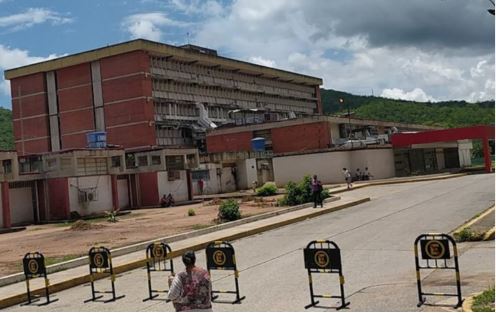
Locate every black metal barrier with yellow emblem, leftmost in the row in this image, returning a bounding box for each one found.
[22,252,58,306]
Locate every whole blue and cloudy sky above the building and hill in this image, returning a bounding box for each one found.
[0,0,495,108]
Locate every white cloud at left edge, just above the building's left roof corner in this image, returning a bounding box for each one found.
[0,44,63,96]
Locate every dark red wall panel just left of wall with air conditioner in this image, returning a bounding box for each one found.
[47,177,70,220]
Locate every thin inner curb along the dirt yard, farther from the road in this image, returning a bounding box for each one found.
[0,196,341,287]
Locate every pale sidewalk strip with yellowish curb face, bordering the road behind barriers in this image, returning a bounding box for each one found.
[0,198,370,309]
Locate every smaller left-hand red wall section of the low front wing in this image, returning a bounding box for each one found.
[207,131,253,153]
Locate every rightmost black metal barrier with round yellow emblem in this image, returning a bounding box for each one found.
[414,233,463,308]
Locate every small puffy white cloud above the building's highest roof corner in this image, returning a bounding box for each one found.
[122,12,188,41]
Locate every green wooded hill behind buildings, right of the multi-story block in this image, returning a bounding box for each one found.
[320,89,494,127]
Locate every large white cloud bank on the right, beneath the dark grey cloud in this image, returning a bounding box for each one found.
[192,0,494,101]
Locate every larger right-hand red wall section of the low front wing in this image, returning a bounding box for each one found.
[271,122,331,153]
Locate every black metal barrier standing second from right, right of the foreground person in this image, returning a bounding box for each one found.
[303,240,350,310]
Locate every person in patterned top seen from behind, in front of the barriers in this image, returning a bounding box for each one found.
[168,251,212,312]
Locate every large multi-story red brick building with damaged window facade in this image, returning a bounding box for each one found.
[5,39,322,156]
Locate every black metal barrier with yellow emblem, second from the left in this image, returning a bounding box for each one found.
[84,247,125,303]
